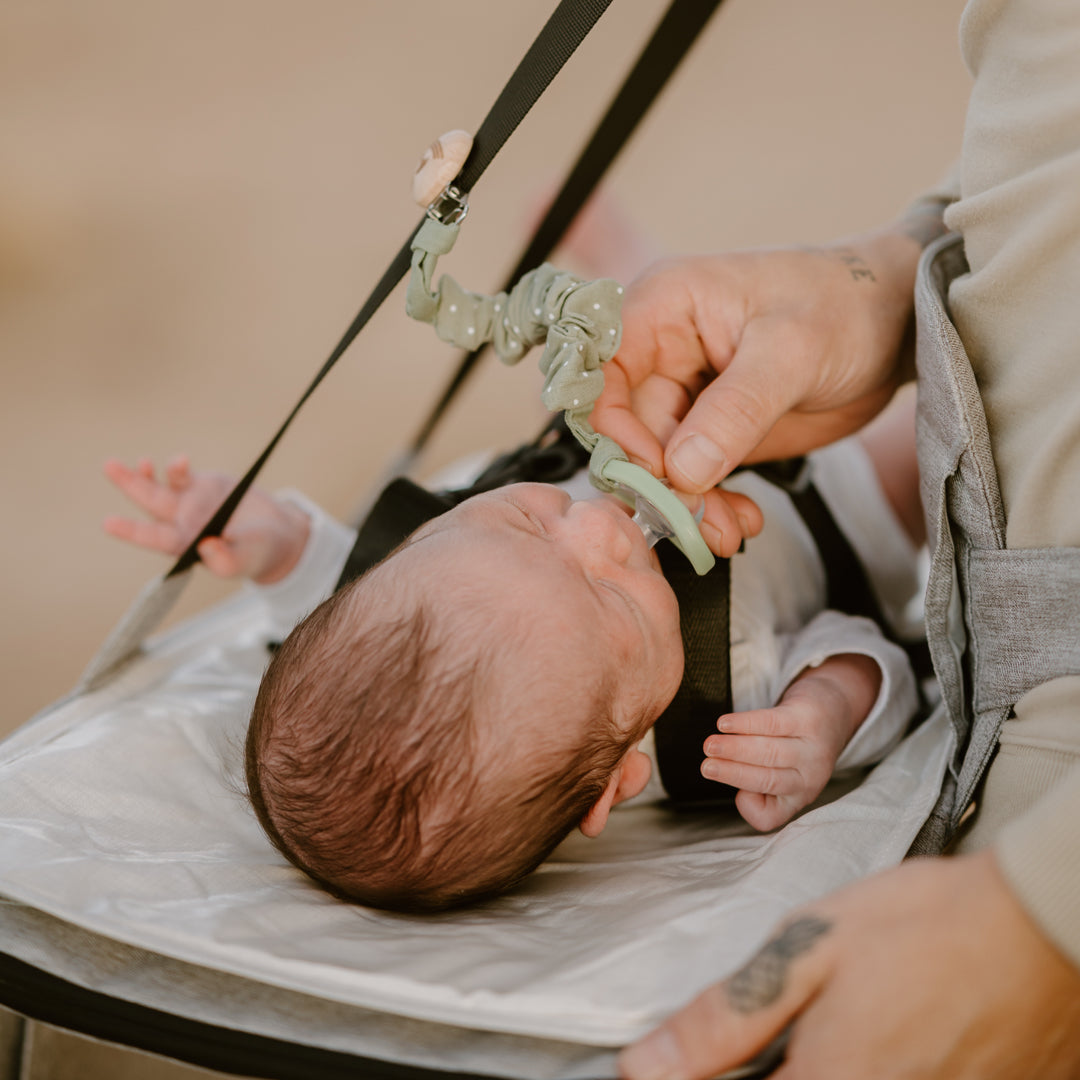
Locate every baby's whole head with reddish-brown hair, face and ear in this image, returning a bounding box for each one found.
[246,484,683,910]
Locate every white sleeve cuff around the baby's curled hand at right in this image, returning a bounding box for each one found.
[773,610,918,770]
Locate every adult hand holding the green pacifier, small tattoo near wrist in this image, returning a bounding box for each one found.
[592,230,921,492]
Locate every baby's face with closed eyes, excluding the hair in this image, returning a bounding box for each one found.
[383,484,683,733]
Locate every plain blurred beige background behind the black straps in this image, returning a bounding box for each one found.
[6,0,968,1077]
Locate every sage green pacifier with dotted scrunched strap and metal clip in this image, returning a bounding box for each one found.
[405,170,716,575]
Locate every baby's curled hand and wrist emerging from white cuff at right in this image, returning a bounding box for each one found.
[701,653,881,832]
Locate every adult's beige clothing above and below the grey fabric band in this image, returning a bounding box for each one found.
[945,0,1080,966]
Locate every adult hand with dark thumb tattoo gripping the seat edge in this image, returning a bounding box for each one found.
[620,851,1080,1080]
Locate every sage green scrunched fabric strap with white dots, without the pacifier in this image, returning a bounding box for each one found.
[405,218,627,490]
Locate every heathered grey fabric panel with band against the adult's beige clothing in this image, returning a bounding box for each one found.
[912,237,1080,854]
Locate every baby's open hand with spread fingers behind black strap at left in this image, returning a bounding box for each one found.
[105,456,310,585]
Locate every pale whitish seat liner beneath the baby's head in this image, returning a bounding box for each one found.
[0,592,951,1058]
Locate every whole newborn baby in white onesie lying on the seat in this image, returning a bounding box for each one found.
[106,388,919,910]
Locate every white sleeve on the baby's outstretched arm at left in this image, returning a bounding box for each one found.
[247,490,356,637]
